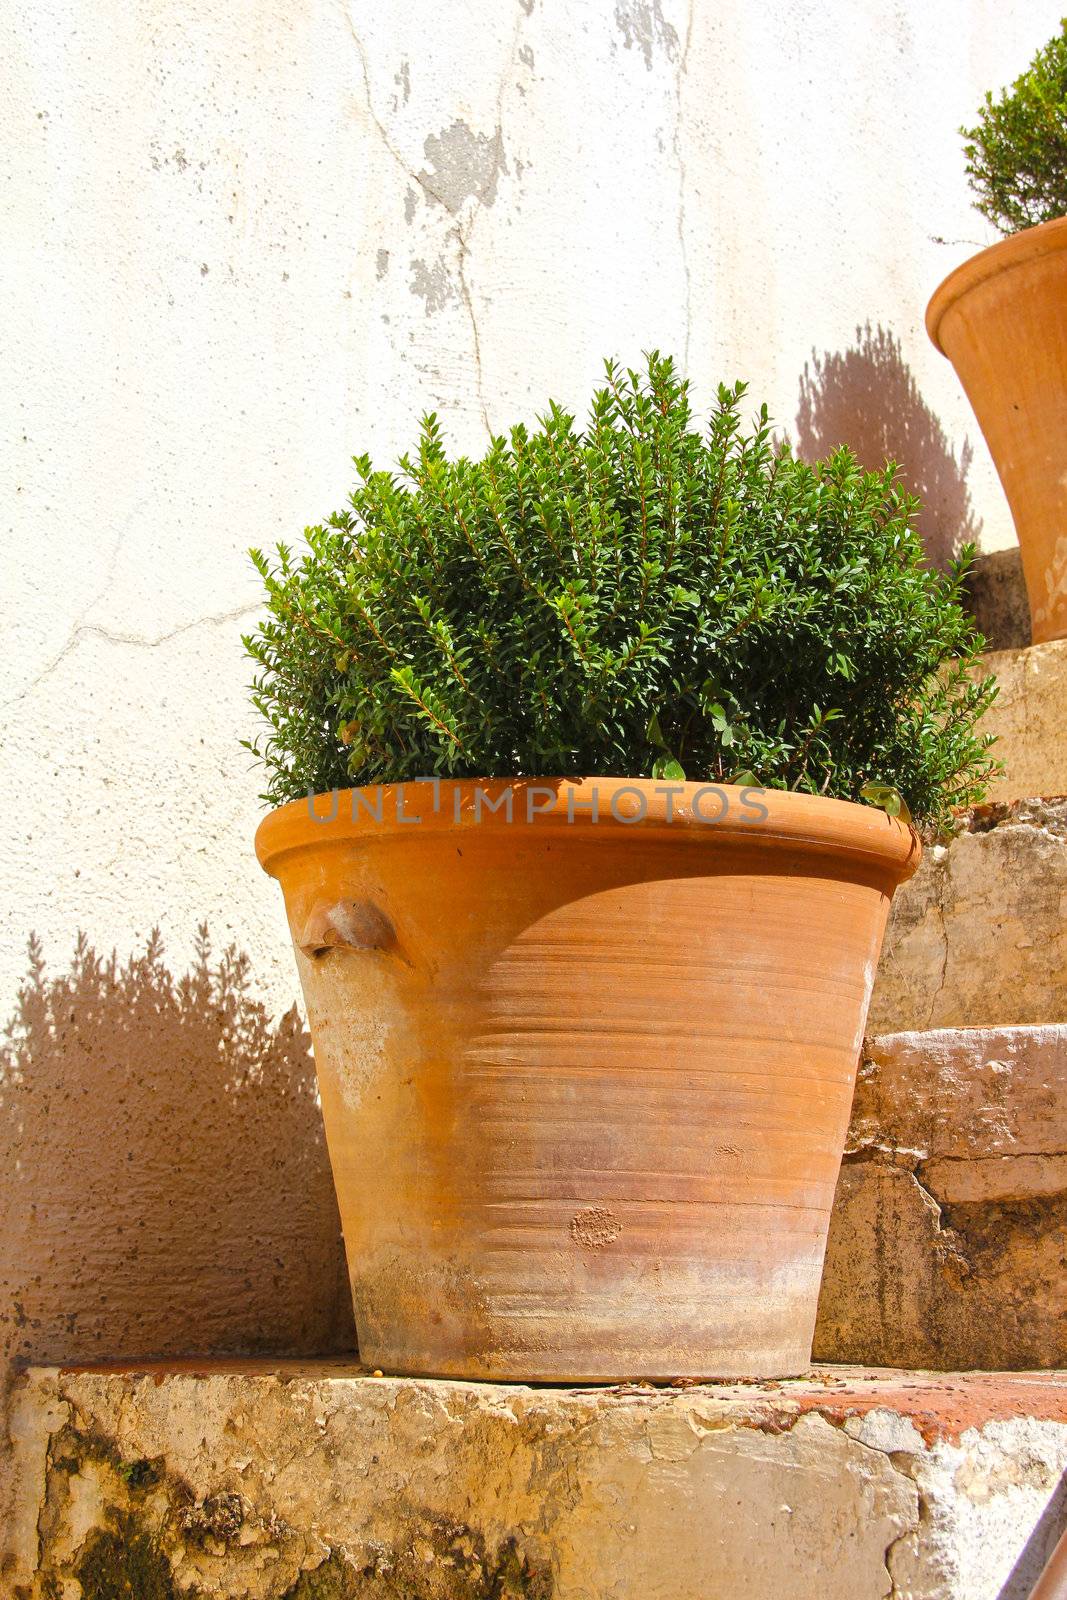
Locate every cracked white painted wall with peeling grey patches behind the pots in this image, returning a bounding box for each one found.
[0,0,1061,1008]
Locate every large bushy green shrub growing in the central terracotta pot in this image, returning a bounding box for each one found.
[245,354,995,819]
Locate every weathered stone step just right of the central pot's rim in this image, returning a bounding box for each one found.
[867,800,1067,1034]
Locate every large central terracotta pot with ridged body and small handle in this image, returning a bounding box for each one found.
[256,779,920,1381]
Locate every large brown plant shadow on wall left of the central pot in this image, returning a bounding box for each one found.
[0,928,355,1363]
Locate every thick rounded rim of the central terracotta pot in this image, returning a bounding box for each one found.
[256,778,921,886]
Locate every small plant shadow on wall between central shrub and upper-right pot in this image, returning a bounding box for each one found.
[797,323,982,570]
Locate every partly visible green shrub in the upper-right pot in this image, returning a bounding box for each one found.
[960,18,1067,234]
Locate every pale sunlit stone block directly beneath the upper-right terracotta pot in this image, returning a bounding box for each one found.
[982,638,1067,800]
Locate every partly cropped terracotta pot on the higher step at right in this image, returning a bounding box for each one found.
[926,218,1067,643]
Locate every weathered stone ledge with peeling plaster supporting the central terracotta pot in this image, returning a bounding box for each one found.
[8,1363,1067,1600]
